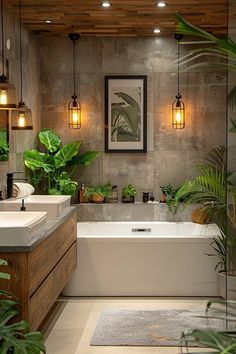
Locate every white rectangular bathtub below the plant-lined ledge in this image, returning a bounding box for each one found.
[63,222,219,296]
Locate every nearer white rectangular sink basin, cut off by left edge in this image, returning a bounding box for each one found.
[0,211,47,246]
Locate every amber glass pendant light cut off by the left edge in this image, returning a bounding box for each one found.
[0,0,16,109]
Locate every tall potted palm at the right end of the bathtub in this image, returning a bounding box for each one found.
[175,146,236,299]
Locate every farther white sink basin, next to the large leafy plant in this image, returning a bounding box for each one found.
[0,195,71,219]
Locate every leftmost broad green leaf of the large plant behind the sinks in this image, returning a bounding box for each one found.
[24,150,54,173]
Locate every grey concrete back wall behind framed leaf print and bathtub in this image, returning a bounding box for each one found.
[40,37,226,200]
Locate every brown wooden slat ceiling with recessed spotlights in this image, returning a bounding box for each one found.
[4,0,227,36]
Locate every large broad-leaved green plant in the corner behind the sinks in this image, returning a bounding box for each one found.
[24,129,98,195]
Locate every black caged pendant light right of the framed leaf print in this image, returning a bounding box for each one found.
[172,33,185,129]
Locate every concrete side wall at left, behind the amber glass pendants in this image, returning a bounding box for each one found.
[0,9,40,198]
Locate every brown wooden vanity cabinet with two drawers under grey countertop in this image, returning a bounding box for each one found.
[0,212,76,330]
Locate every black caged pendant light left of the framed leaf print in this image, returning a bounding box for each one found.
[68,33,81,129]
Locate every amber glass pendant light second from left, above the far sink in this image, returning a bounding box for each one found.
[11,0,33,130]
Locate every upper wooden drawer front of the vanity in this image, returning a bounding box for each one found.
[29,214,76,295]
